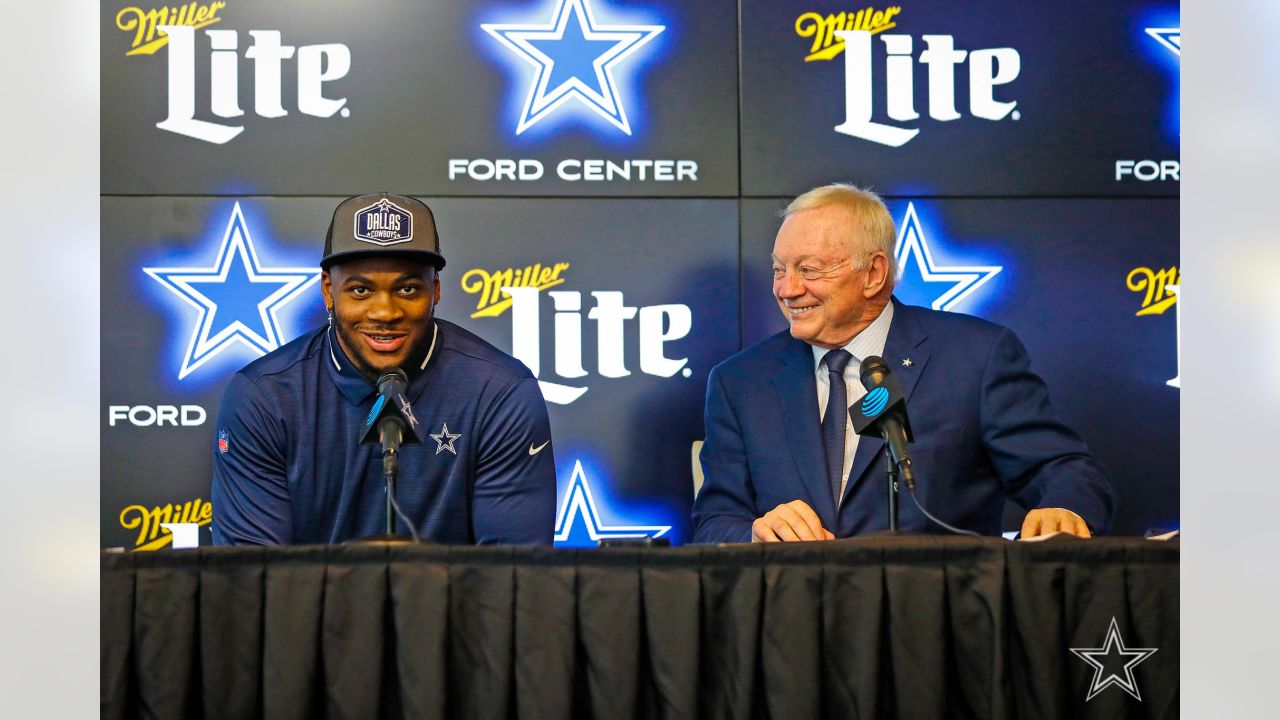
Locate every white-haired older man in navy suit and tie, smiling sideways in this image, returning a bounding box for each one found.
[694,184,1115,542]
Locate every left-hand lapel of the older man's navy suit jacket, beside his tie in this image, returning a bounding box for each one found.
[772,341,836,528]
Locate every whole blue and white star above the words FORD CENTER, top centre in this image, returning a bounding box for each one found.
[480,0,666,135]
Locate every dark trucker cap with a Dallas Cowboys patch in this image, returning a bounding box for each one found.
[320,192,444,270]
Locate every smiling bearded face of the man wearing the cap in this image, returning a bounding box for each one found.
[320,256,440,382]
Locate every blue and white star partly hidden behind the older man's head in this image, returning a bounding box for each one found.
[893,202,1004,310]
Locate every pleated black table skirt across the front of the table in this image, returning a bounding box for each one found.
[101,536,1179,720]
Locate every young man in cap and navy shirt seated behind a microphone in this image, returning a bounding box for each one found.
[211,192,556,544]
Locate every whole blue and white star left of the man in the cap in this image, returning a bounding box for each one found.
[142,202,320,380]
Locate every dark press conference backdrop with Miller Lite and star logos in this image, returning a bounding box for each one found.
[101,0,1181,550]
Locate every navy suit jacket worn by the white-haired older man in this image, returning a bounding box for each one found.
[692,300,1115,542]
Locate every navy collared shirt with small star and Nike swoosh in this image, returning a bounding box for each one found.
[210,319,556,544]
